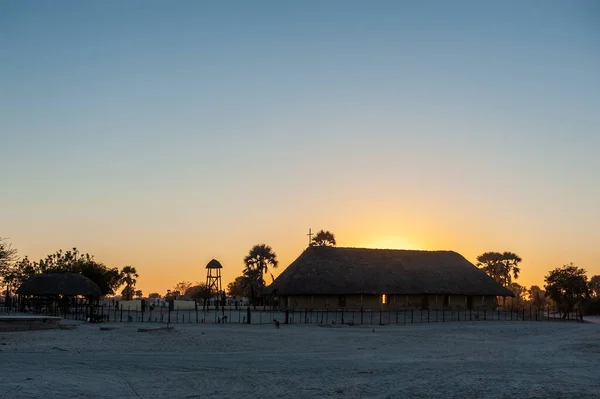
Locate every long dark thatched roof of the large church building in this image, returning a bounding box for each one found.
[267,247,514,296]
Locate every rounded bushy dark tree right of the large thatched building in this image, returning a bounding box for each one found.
[544,263,590,319]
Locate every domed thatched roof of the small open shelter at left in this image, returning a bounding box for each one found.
[17,273,102,296]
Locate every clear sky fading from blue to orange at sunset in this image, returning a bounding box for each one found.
[0,0,600,294]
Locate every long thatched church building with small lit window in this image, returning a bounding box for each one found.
[267,247,514,309]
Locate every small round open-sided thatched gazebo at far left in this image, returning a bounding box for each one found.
[17,273,102,314]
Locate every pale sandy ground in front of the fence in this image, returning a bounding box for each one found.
[0,322,600,399]
